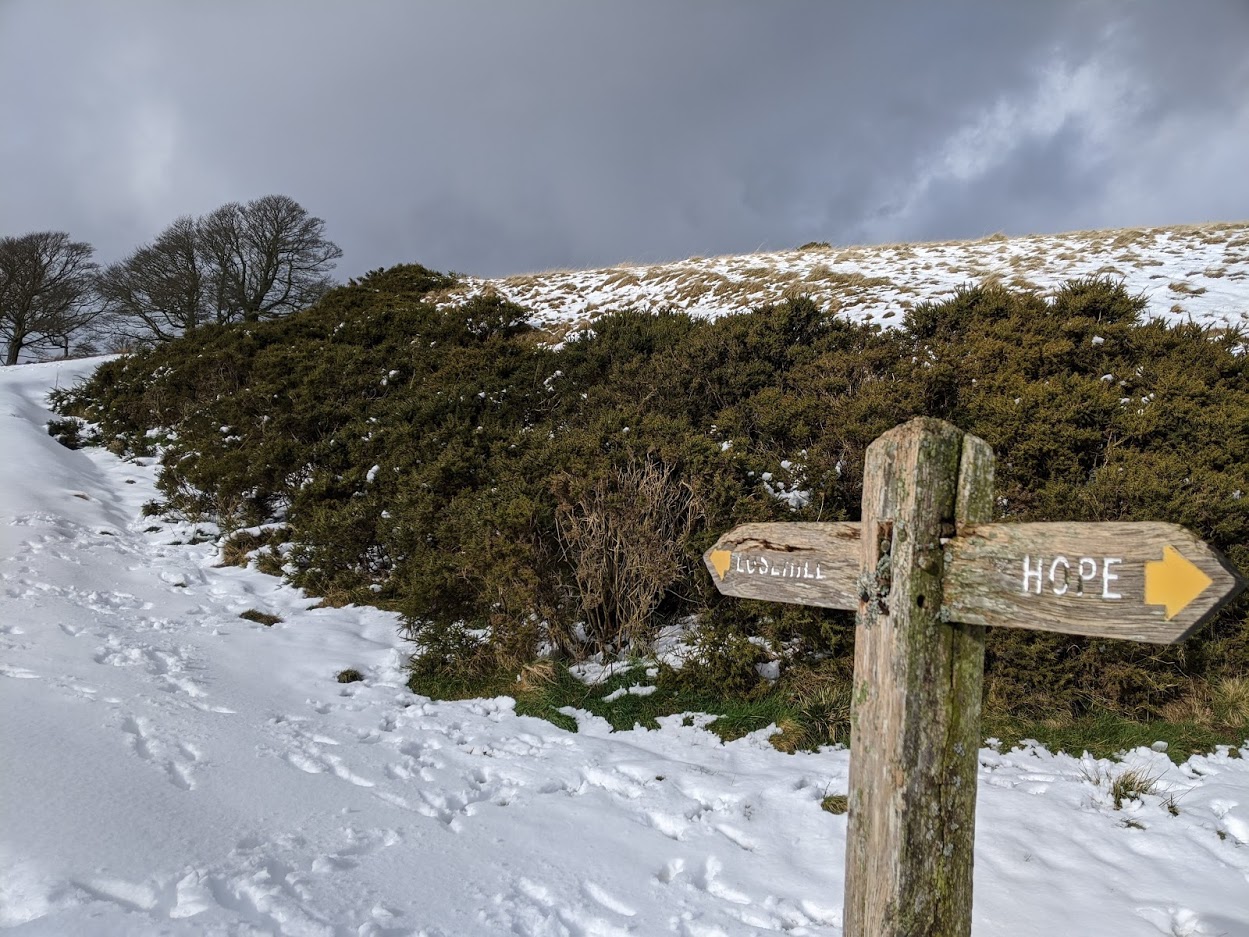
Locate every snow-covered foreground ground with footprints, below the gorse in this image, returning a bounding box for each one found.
[0,354,1249,937]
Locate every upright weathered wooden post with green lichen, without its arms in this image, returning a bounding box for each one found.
[844,419,993,937]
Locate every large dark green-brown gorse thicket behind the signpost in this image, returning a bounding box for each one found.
[59,265,1249,725]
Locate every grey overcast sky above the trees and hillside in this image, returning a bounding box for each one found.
[0,0,1249,279]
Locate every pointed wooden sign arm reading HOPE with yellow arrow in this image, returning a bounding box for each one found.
[942,522,1244,643]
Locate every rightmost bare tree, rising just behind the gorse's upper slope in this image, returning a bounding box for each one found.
[199,195,342,321]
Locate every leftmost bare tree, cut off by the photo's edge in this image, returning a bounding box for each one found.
[0,231,100,365]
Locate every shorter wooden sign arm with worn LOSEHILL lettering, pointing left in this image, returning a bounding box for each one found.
[703,522,861,610]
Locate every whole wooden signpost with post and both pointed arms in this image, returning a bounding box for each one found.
[703,419,1245,937]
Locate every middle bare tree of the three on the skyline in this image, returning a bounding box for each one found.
[99,216,209,342]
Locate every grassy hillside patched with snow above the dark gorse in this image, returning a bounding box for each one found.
[445,222,1249,332]
